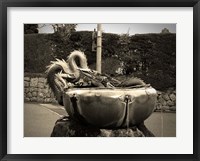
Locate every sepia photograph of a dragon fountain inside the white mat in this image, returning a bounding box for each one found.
[23,23,176,137]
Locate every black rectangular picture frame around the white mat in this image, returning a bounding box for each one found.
[0,0,200,161]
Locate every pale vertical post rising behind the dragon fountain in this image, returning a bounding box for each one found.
[96,24,102,73]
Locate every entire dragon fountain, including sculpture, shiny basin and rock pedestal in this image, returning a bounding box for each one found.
[47,51,157,136]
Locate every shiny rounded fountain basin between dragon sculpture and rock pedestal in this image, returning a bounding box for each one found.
[63,87,157,128]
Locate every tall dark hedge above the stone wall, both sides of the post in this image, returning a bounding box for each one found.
[25,31,176,89]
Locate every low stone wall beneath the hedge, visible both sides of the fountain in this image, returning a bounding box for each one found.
[24,76,176,111]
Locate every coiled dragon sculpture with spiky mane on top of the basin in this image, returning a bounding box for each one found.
[46,50,146,105]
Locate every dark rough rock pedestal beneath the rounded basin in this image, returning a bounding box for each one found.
[51,116,154,137]
